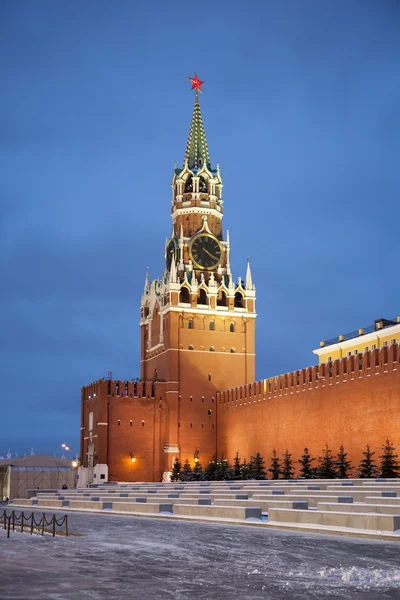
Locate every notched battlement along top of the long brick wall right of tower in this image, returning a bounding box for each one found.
[217,344,400,408]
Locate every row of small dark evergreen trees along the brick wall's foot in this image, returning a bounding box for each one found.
[171,440,400,481]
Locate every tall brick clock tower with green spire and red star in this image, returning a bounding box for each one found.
[140,75,256,471]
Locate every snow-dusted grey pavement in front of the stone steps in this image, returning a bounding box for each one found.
[0,513,400,600]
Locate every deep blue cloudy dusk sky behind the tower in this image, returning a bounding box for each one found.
[0,0,400,456]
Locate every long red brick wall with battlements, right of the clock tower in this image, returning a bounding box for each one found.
[217,346,400,466]
